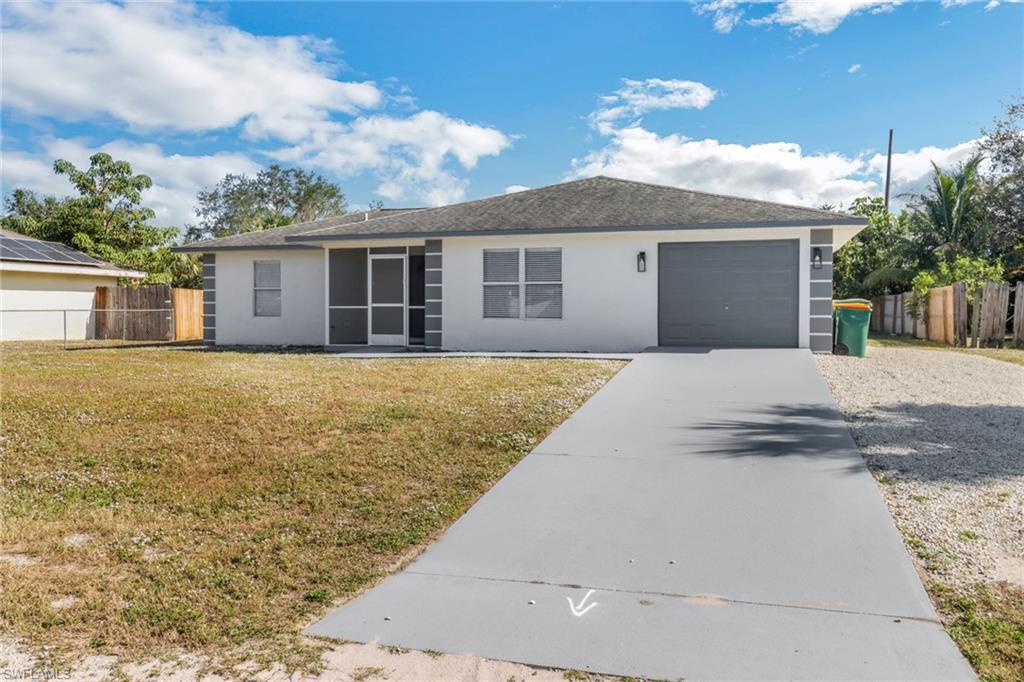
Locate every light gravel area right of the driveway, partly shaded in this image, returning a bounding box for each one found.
[815,347,1024,587]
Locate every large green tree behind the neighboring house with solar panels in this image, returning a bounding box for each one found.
[0,153,200,286]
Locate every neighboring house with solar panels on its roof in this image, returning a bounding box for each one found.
[0,229,145,341]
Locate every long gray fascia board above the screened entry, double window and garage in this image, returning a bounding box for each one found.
[285,218,867,244]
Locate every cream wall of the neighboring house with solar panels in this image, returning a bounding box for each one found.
[0,268,117,341]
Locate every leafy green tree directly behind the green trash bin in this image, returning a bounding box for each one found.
[833,197,913,298]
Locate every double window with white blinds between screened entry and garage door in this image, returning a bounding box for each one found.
[483,249,562,319]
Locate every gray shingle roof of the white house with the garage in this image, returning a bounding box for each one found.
[178,176,867,251]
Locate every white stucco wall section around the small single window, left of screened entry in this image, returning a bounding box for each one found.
[215,249,326,345]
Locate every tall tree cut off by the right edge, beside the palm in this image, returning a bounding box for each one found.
[978,97,1024,282]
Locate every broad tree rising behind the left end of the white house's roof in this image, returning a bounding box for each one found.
[185,164,345,242]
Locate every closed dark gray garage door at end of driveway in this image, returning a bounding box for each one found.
[657,240,800,347]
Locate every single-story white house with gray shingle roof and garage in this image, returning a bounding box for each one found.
[178,177,866,351]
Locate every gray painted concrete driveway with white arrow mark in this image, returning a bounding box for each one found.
[307,350,974,679]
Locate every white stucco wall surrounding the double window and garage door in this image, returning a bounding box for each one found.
[442,227,810,351]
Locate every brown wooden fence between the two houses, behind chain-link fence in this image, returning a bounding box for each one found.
[94,285,203,341]
